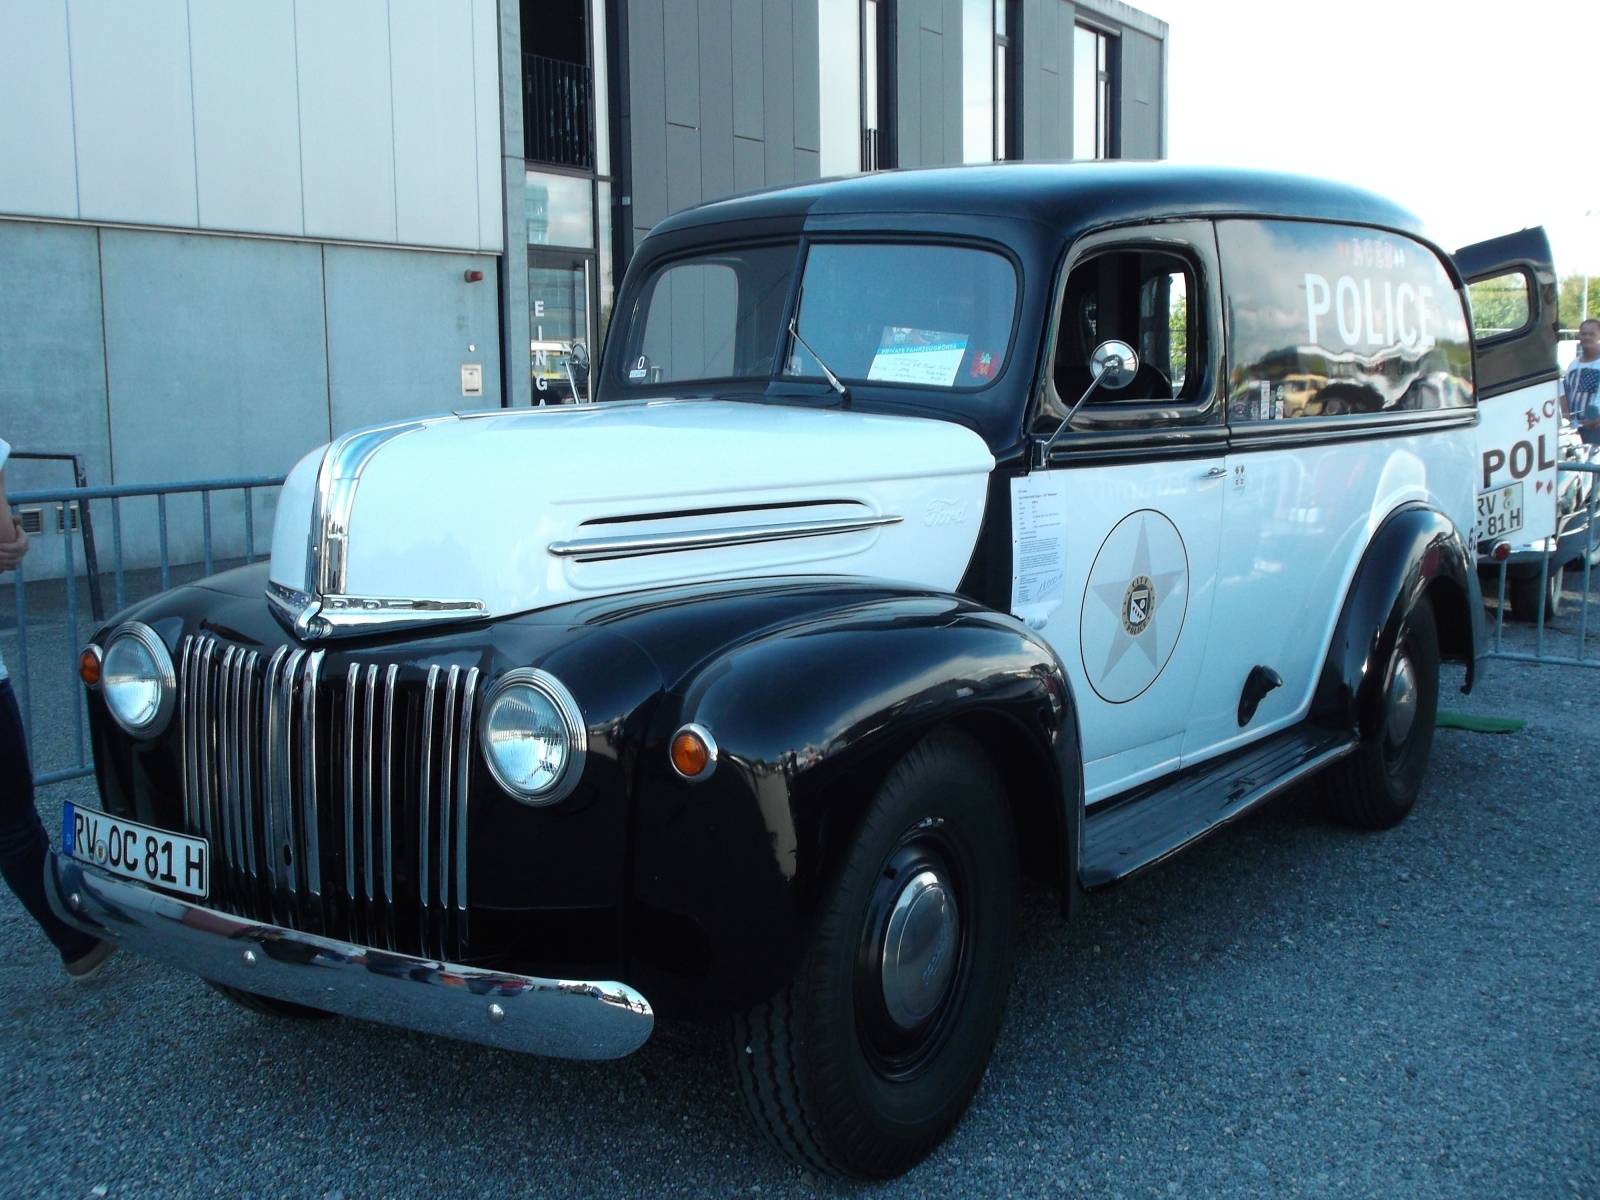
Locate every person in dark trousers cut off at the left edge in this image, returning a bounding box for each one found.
[0,438,117,979]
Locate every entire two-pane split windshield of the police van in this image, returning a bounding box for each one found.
[614,242,1016,390]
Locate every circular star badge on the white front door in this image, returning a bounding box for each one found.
[1078,509,1189,704]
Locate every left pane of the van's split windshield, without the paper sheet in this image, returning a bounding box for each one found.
[619,242,798,387]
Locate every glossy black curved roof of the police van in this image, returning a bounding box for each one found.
[653,162,1422,243]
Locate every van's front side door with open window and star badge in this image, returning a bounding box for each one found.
[1011,222,1227,803]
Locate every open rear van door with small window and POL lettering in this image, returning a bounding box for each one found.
[1454,227,1555,560]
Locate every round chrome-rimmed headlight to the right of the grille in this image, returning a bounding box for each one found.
[478,667,589,805]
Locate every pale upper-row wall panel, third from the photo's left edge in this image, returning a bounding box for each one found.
[189,0,306,235]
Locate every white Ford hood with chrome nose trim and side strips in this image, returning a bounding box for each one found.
[267,400,994,638]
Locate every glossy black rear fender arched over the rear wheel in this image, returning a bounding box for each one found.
[1310,504,1483,738]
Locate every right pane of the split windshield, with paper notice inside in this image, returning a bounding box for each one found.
[784,242,1016,389]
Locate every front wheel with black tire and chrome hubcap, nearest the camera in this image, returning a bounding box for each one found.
[728,730,1018,1179]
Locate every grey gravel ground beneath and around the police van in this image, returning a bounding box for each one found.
[0,611,1600,1200]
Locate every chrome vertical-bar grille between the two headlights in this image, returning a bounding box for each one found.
[179,634,478,958]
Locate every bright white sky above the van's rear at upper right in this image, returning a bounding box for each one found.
[1134,0,1600,275]
